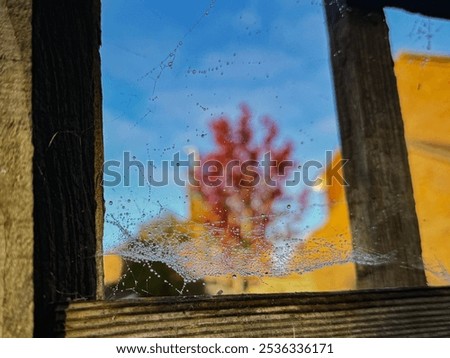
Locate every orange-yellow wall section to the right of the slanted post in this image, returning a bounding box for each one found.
[395,54,450,286]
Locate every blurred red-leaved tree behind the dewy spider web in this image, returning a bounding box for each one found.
[195,105,306,249]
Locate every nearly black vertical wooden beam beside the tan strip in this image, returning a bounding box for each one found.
[32,0,103,336]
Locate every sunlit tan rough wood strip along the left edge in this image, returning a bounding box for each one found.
[0,0,33,337]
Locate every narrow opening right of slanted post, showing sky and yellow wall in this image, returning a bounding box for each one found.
[387,10,450,286]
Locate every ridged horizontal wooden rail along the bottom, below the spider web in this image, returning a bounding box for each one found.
[57,287,450,337]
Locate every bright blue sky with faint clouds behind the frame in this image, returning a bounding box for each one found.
[101,0,450,249]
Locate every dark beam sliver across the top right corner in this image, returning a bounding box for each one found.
[348,0,450,20]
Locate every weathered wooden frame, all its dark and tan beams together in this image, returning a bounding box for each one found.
[0,0,450,337]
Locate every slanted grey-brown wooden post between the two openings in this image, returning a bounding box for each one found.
[325,0,426,288]
